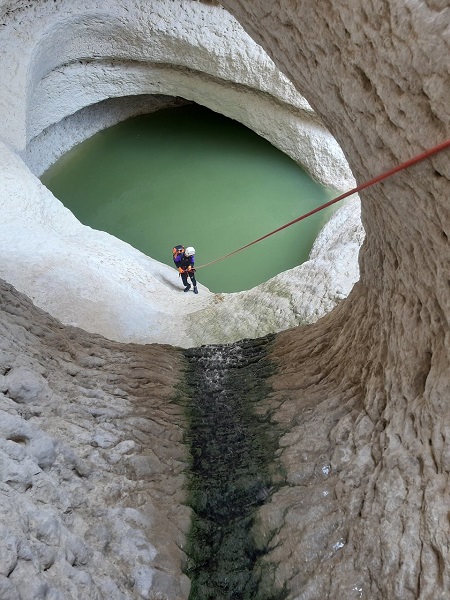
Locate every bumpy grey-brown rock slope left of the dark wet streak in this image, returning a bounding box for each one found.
[0,282,190,600]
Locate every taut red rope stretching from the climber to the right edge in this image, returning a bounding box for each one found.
[196,139,450,269]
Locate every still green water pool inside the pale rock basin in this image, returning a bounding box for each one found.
[42,105,336,292]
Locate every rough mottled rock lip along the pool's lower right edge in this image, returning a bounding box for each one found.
[188,199,364,345]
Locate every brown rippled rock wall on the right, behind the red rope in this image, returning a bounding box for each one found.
[224,0,450,600]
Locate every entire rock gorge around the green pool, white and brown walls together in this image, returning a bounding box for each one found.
[0,0,450,600]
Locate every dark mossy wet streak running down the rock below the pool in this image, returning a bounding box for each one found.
[181,338,285,600]
